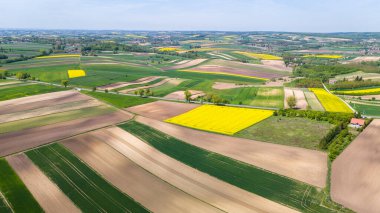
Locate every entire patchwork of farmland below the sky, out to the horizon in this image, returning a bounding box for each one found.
[0,28,380,213]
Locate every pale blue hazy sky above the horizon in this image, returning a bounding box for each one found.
[0,0,380,32]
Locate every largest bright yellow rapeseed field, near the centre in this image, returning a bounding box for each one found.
[165,105,273,135]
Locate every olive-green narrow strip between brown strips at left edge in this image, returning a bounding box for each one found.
[0,106,115,134]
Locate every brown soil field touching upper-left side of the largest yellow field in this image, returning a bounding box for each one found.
[126,101,199,120]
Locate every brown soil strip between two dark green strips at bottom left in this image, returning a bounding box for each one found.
[6,154,81,213]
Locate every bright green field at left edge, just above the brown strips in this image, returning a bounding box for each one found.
[0,84,66,101]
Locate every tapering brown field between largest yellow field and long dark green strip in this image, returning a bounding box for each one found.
[136,116,327,188]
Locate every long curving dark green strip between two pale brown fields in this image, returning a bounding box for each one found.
[120,121,346,212]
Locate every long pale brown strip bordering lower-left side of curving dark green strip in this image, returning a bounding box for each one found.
[79,127,295,212]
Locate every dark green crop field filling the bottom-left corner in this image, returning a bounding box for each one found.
[0,159,43,212]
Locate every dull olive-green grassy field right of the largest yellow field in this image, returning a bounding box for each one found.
[235,116,333,149]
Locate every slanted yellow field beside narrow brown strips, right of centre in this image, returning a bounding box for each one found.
[309,88,353,113]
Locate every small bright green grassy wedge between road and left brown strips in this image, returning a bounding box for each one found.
[82,91,155,108]
